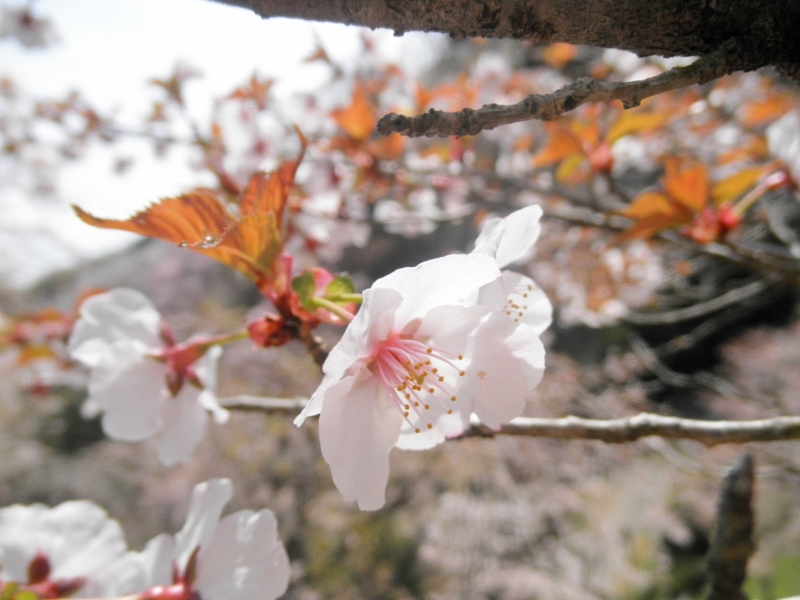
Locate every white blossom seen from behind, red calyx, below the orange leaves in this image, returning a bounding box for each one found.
[68,288,228,466]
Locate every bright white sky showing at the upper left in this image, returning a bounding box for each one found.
[0,0,441,287]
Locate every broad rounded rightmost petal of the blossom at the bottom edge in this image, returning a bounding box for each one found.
[196,509,289,600]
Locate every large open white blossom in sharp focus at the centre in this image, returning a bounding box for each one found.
[295,252,544,510]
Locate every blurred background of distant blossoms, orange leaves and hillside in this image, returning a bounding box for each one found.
[0,2,800,600]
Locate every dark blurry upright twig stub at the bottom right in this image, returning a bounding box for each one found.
[706,454,756,600]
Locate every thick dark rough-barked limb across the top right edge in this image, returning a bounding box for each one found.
[217,0,800,77]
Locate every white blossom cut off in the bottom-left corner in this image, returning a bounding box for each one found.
[0,500,127,598]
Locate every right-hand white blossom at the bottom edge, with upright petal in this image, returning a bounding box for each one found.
[95,479,289,600]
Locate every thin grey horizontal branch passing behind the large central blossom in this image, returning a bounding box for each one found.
[220,396,800,446]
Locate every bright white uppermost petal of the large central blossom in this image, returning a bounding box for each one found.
[373,253,500,324]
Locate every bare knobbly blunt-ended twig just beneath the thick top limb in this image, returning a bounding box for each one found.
[378,40,747,137]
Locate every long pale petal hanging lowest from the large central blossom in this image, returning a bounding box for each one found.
[319,368,403,510]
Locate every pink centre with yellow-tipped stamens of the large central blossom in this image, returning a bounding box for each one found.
[370,334,465,433]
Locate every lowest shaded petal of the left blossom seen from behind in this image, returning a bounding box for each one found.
[158,383,208,467]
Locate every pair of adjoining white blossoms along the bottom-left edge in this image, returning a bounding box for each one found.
[0,479,289,600]
